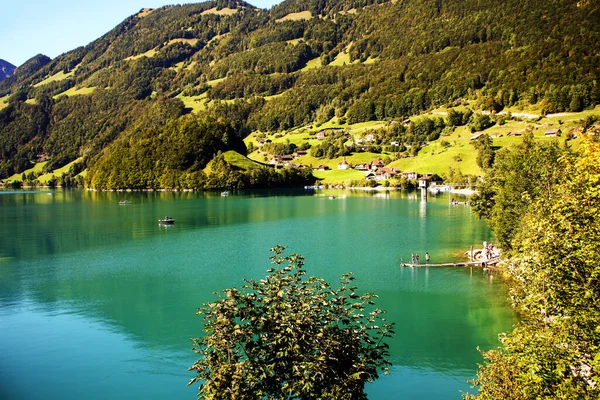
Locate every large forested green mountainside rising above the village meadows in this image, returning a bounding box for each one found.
[0,0,600,188]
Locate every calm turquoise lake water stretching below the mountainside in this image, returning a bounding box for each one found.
[0,190,514,399]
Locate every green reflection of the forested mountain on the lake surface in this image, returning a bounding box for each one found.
[0,191,512,398]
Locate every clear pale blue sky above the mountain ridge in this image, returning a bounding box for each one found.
[0,0,281,67]
